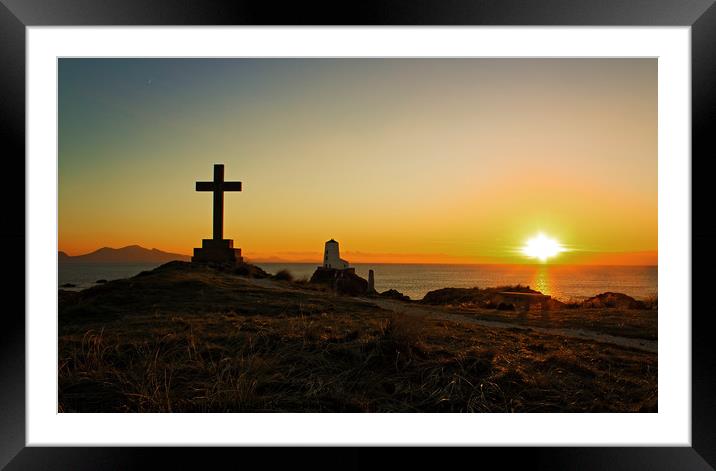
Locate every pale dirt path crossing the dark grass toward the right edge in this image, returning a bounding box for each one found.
[356,298,658,353]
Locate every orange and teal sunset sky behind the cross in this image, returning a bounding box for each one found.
[58,59,657,264]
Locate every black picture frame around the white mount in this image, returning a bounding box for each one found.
[0,0,716,470]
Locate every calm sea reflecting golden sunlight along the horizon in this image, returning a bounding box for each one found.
[58,262,658,302]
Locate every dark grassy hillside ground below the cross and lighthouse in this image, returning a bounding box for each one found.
[58,262,657,412]
